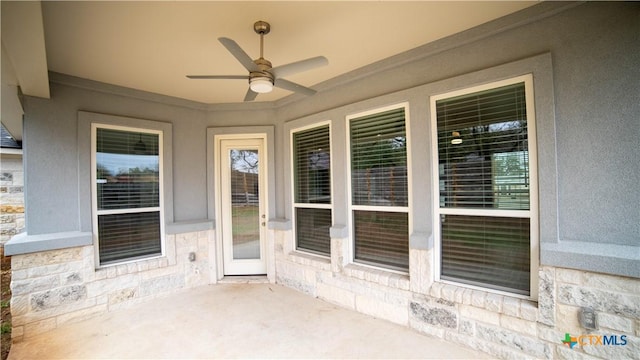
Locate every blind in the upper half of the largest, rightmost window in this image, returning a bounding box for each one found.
[436,83,529,210]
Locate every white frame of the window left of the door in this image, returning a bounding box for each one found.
[91,123,165,269]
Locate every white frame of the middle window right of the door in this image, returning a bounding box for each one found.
[345,102,413,275]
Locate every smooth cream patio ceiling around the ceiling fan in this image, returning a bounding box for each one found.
[17,1,536,104]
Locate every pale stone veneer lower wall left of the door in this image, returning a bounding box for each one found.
[11,230,216,341]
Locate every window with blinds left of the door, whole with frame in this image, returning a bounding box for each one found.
[92,124,164,266]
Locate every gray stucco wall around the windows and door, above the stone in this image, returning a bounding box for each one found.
[16,2,640,277]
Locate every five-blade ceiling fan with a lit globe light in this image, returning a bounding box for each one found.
[187,21,329,101]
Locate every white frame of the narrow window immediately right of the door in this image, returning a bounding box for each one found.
[289,120,335,259]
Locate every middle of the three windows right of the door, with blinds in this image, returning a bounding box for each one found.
[348,106,409,271]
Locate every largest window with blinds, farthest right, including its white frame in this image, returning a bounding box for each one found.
[431,76,537,296]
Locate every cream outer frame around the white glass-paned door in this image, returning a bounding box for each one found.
[207,126,276,283]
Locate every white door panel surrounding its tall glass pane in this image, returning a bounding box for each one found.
[219,139,267,275]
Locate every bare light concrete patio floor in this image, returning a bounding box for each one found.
[9,283,488,360]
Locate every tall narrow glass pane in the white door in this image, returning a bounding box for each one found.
[229,149,261,259]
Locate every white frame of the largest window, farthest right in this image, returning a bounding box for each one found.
[430,74,540,300]
